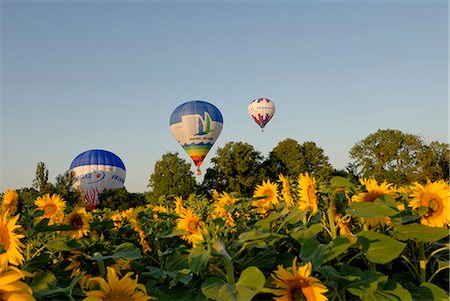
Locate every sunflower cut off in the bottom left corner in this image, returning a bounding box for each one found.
[0,266,35,301]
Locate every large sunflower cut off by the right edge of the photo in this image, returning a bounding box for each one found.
[409,180,450,227]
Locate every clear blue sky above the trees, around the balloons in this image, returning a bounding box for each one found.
[0,0,449,192]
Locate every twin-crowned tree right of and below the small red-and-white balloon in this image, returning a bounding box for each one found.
[265,138,333,180]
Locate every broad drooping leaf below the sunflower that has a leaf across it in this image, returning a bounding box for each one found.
[357,231,406,264]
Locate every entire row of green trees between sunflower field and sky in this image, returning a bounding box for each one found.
[8,129,450,210]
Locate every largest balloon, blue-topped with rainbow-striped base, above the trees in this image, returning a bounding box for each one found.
[169,100,223,175]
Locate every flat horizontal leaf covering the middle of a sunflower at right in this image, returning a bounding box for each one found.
[346,199,399,218]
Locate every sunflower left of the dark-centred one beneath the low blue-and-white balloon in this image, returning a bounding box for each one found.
[34,193,66,225]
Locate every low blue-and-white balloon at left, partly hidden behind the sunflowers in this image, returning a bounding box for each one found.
[70,149,125,210]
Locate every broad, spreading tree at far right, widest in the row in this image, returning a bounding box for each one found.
[350,129,444,184]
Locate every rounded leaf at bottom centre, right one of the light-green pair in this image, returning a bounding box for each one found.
[236,266,266,301]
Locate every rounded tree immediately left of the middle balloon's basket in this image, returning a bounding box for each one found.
[148,152,196,200]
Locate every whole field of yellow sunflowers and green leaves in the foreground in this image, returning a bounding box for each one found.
[0,173,450,301]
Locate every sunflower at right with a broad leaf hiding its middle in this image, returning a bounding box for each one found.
[352,178,397,227]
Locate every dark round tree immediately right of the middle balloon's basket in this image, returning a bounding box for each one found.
[202,142,265,196]
